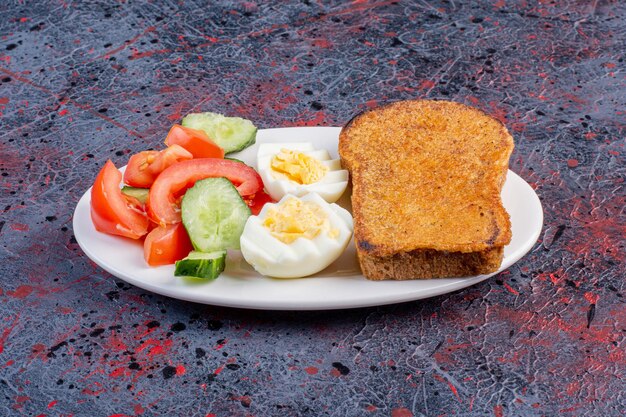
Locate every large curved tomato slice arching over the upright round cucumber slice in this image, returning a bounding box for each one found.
[148,158,263,225]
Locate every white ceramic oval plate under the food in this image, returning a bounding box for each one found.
[74,127,543,310]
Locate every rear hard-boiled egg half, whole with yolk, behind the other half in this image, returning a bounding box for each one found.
[257,142,348,203]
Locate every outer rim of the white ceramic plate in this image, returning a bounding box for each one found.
[72,126,544,311]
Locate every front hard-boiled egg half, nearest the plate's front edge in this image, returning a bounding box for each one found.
[240,193,353,278]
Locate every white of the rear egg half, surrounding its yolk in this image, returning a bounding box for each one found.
[257,142,348,203]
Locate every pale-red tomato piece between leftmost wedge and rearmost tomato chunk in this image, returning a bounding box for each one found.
[124,145,193,188]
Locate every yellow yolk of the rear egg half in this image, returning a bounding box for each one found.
[270,149,328,184]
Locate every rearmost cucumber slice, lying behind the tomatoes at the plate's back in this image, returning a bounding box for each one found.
[182,112,257,153]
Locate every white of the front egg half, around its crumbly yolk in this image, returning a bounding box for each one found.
[240,193,353,278]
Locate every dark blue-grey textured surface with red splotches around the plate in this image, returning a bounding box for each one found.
[0,0,626,417]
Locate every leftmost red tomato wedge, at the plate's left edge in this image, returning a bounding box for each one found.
[91,160,149,239]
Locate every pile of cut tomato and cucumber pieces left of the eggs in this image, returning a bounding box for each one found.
[90,113,264,279]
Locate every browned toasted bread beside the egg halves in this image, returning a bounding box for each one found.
[339,100,514,280]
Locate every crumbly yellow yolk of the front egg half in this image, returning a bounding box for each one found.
[263,198,339,244]
